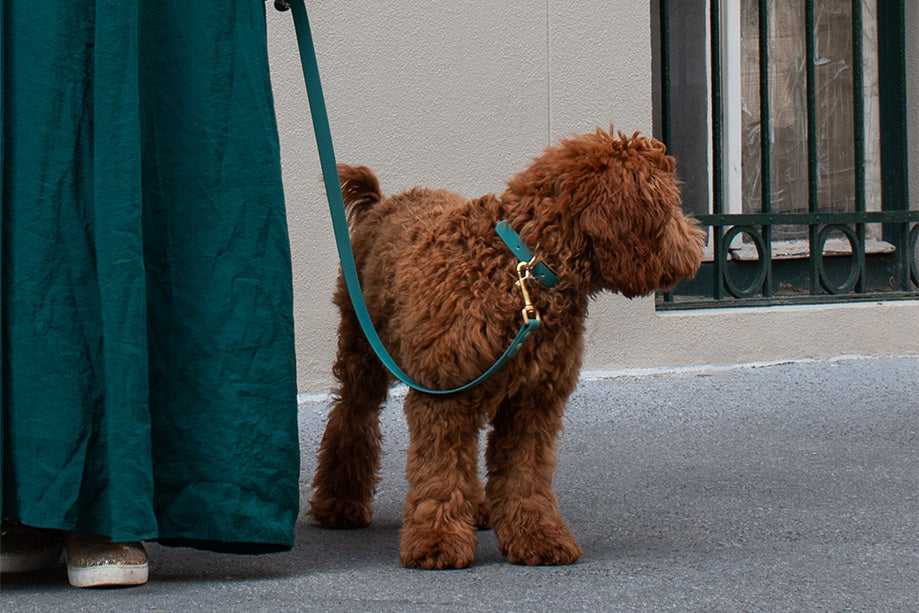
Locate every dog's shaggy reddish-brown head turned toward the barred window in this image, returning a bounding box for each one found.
[508,129,704,298]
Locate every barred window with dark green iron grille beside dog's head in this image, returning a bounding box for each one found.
[652,0,919,309]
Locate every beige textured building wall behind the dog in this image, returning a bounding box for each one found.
[269,0,919,393]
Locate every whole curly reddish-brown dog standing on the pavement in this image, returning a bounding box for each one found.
[309,129,703,569]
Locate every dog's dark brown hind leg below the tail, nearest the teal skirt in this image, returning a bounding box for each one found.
[309,309,389,528]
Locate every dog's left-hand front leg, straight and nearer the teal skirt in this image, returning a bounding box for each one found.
[399,390,482,569]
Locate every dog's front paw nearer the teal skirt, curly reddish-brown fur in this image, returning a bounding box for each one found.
[399,527,478,570]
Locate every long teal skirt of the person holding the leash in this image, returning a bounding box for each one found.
[0,0,299,552]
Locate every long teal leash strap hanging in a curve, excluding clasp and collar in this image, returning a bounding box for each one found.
[290,0,540,395]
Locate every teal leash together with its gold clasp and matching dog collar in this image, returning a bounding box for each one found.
[290,0,558,394]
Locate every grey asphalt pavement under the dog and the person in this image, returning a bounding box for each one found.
[0,354,919,613]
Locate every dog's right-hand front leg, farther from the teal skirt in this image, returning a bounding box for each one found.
[485,394,582,566]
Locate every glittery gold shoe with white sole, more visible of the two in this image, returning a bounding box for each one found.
[66,532,147,587]
